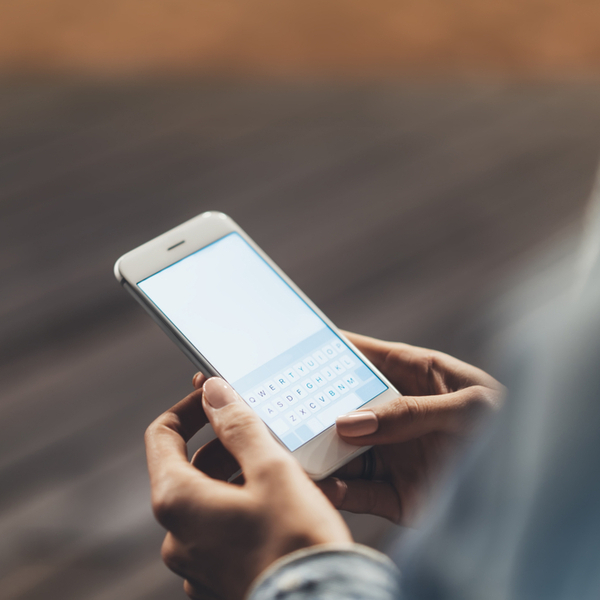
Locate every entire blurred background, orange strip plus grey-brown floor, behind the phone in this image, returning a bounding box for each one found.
[0,0,600,600]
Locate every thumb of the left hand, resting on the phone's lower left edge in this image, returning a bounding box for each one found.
[202,377,291,480]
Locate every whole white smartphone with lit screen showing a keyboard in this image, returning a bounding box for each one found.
[115,212,399,479]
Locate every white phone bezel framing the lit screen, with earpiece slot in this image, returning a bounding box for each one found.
[114,211,400,480]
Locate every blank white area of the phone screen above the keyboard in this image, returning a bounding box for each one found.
[138,233,326,382]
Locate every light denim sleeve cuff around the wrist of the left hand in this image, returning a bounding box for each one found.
[247,544,400,600]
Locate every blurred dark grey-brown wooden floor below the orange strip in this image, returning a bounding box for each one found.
[0,82,600,600]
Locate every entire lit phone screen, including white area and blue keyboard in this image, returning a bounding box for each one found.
[137,233,388,451]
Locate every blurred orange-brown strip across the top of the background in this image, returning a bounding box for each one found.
[0,0,600,81]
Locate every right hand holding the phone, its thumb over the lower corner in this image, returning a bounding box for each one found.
[319,333,503,525]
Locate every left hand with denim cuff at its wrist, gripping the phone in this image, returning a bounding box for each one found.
[146,376,352,600]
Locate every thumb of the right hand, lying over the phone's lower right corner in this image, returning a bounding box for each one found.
[336,385,499,446]
